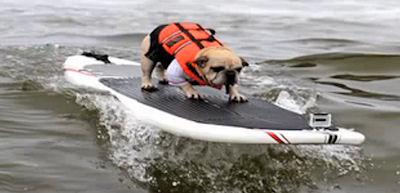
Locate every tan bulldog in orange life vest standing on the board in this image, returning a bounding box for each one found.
[141,22,249,103]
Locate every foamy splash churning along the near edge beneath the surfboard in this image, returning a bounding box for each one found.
[71,88,364,192]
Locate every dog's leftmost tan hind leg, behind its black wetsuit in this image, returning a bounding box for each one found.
[140,35,156,91]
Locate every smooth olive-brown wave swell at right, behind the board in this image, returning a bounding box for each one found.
[260,52,400,111]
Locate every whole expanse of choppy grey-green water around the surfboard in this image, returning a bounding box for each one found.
[0,0,400,193]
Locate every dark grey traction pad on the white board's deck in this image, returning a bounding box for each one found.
[100,78,311,130]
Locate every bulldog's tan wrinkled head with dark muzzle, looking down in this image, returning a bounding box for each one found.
[196,47,248,85]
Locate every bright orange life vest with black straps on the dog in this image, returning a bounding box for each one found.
[158,22,223,88]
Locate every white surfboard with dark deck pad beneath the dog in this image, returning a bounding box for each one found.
[64,55,364,145]
